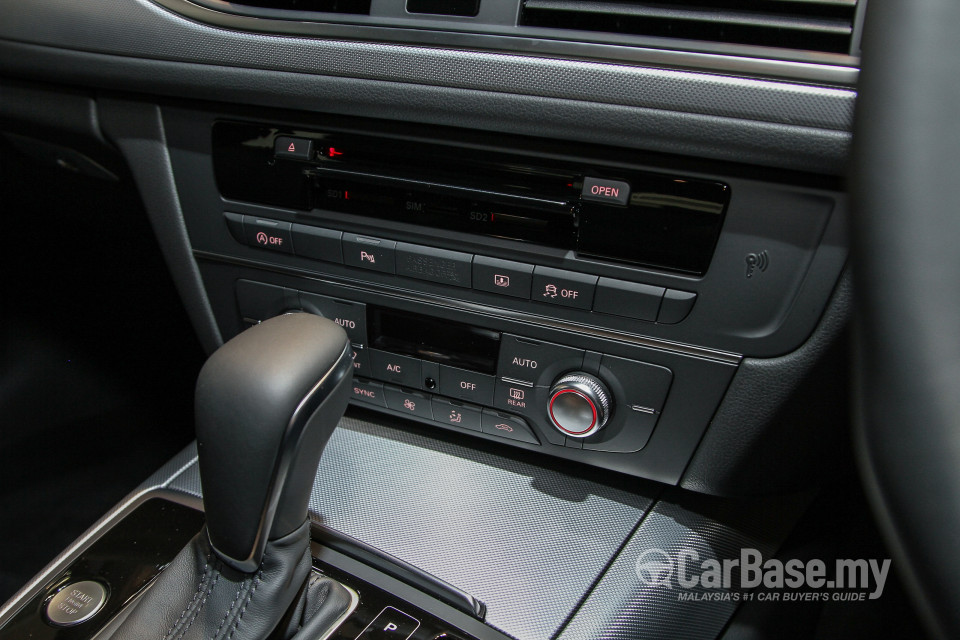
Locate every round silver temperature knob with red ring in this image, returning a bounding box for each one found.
[547,371,613,438]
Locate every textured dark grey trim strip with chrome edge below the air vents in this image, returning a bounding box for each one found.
[0,0,856,131]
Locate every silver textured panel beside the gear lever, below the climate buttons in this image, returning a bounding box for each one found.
[169,417,651,640]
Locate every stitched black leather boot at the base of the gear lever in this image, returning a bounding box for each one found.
[110,523,350,640]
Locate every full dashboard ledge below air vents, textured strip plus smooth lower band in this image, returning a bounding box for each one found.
[0,0,855,172]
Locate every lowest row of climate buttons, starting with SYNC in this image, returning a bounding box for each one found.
[353,378,540,445]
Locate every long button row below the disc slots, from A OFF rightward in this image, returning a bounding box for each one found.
[224,213,697,324]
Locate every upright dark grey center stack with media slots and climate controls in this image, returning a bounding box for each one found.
[164,108,846,484]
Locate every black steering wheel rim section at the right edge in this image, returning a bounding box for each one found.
[854,0,960,638]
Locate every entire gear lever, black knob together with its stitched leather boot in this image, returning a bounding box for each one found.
[110,313,353,640]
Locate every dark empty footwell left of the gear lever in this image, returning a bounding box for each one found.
[0,140,203,602]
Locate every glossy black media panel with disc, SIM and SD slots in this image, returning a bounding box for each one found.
[213,122,730,275]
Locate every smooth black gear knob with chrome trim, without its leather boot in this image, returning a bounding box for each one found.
[195,313,352,568]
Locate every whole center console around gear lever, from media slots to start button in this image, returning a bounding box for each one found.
[0,99,846,640]
